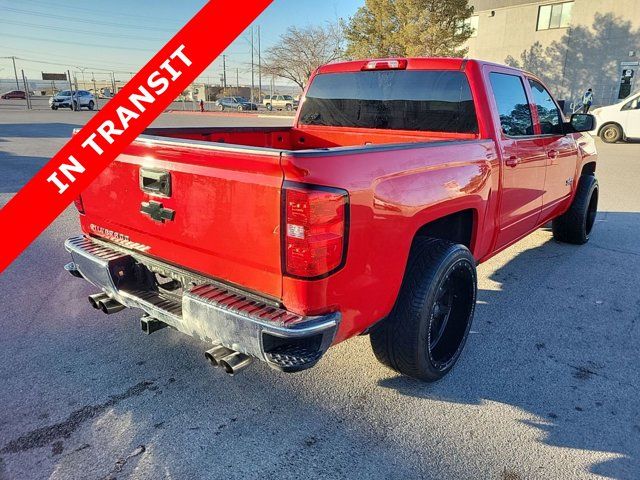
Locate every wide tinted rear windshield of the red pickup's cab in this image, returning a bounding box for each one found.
[300,70,478,133]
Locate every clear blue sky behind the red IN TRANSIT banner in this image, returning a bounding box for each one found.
[0,0,364,85]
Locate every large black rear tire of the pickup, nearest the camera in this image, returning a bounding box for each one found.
[371,238,478,382]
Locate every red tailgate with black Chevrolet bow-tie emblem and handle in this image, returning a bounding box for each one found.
[81,137,283,299]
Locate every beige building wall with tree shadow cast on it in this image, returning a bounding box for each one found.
[466,0,640,104]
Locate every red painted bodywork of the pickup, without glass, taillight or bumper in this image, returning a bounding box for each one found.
[77,59,596,342]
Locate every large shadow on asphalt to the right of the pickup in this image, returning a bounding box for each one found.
[379,212,640,479]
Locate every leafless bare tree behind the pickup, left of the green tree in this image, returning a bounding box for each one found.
[264,24,344,88]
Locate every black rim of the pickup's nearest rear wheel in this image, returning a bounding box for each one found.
[428,260,475,370]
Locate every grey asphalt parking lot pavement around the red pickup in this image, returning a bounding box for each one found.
[0,112,640,479]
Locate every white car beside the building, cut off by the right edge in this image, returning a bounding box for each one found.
[589,92,640,143]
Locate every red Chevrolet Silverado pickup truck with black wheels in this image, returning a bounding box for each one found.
[65,58,598,381]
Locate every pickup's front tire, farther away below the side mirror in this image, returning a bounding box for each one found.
[552,175,600,245]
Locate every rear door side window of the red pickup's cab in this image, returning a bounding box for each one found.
[489,72,533,137]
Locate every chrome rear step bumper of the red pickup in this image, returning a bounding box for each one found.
[65,236,340,371]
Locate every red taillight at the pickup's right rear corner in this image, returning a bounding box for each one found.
[282,183,349,279]
